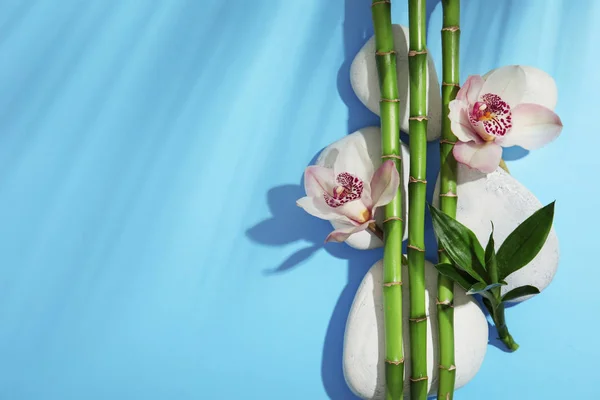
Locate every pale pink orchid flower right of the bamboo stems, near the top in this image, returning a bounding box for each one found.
[449,65,562,173]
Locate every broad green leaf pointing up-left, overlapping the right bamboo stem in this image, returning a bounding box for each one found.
[429,205,488,282]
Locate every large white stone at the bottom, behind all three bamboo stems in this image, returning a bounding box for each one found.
[343,261,488,399]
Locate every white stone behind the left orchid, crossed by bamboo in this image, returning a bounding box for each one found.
[316,126,409,250]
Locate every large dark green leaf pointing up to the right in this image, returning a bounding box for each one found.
[496,202,555,279]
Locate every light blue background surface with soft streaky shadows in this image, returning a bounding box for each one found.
[0,0,600,400]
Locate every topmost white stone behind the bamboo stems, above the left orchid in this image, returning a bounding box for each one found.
[350,25,442,141]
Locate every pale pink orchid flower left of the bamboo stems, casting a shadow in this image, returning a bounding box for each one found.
[296,160,400,242]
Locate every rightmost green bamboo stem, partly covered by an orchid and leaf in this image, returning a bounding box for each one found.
[437,0,460,400]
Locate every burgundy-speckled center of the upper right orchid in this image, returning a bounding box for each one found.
[469,93,512,142]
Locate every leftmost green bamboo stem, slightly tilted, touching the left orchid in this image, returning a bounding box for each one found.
[371,0,404,400]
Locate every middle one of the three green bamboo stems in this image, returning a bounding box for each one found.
[408,0,429,400]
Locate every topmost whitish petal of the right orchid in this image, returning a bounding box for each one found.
[481,65,527,108]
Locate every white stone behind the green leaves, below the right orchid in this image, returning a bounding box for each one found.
[434,164,559,303]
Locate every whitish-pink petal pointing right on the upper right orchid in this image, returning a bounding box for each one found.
[499,103,562,150]
